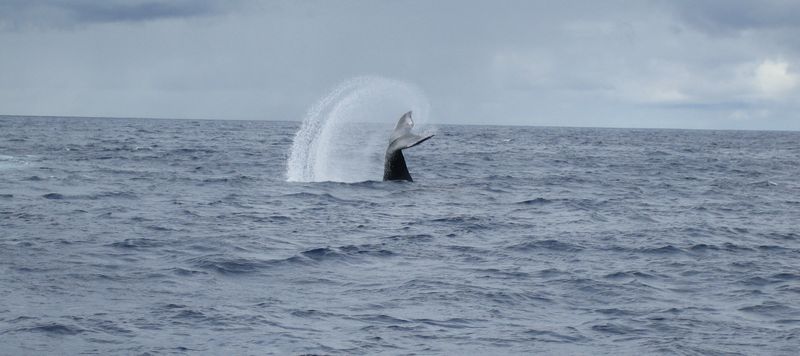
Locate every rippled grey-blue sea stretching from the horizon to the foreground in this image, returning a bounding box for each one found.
[0,117,800,355]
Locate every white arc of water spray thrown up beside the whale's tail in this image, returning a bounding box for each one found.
[286,76,430,182]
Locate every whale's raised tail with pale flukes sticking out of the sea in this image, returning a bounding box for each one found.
[383,111,433,182]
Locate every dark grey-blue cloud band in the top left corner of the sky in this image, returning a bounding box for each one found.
[0,0,241,30]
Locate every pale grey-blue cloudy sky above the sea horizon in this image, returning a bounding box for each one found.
[0,0,800,130]
